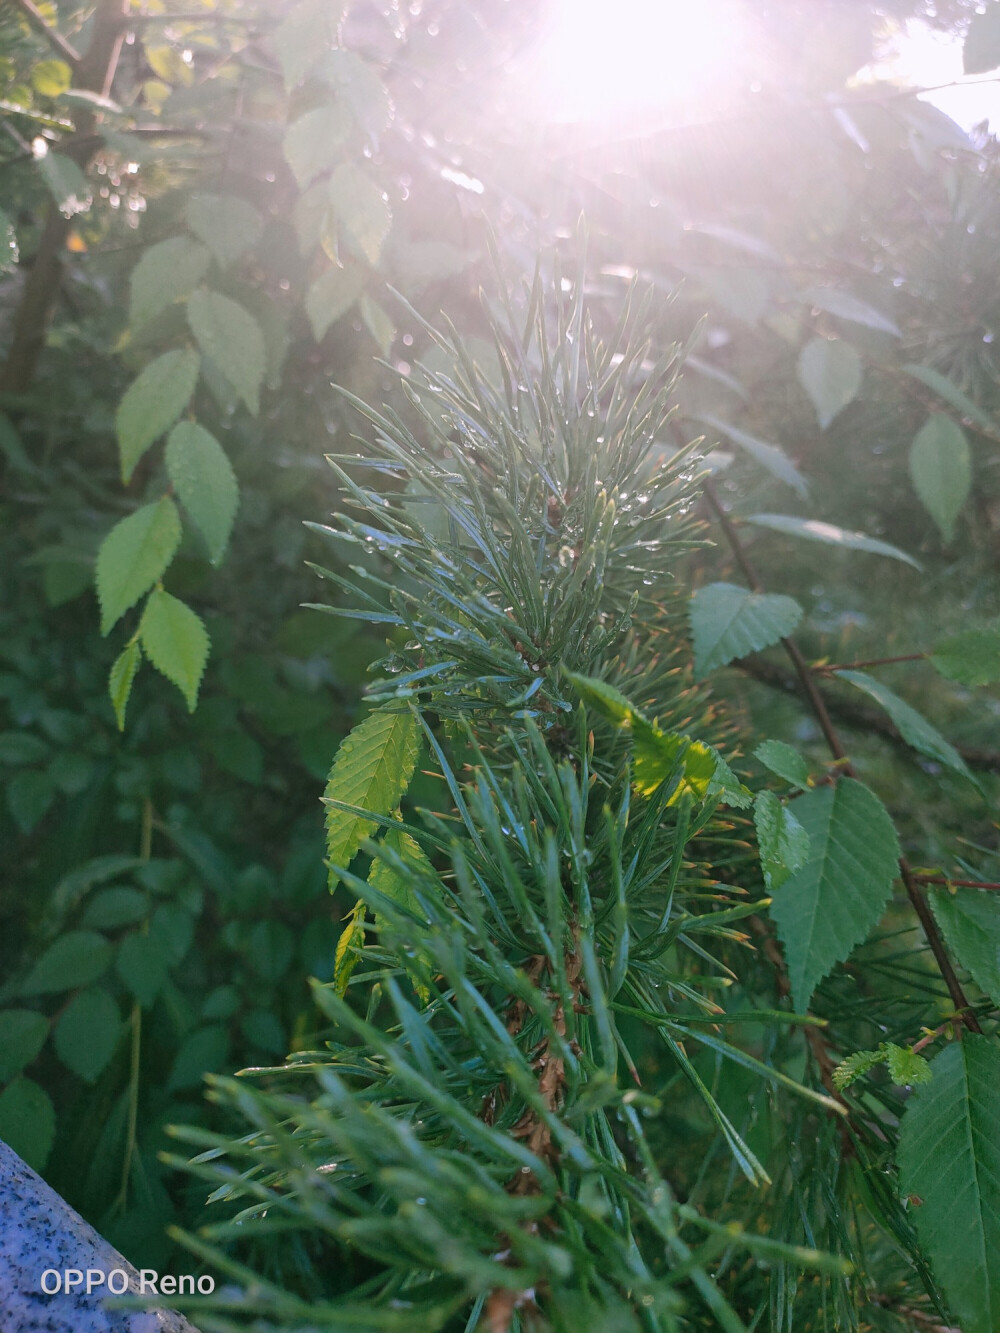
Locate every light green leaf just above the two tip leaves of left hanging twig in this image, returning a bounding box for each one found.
[96,496,180,637]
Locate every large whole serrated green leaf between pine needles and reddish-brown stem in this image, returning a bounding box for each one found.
[771,777,900,1013]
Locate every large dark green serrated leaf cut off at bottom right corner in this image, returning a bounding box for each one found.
[897,1033,1000,1333]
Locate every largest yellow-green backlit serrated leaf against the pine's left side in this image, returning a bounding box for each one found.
[324,709,420,889]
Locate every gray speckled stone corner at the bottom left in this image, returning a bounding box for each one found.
[0,1142,204,1333]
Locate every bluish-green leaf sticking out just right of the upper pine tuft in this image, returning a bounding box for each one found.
[691,583,803,680]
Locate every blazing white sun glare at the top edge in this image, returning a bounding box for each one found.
[512,0,740,123]
